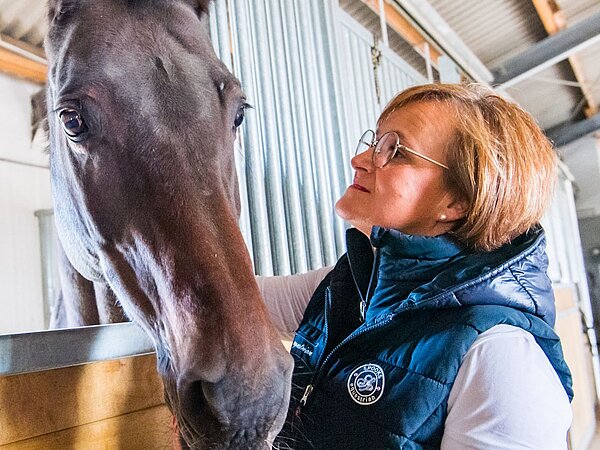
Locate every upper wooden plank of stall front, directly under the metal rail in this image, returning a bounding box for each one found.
[0,355,163,445]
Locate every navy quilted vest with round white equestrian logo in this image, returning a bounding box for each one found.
[276,228,573,450]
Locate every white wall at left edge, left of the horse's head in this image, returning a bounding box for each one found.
[0,73,52,333]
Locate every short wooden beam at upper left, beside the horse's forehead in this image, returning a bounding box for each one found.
[0,35,48,84]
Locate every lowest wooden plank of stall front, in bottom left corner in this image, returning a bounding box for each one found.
[0,405,174,450]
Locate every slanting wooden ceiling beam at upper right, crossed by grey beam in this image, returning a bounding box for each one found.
[532,0,598,118]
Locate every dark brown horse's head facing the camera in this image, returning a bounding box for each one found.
[45,0,292,449]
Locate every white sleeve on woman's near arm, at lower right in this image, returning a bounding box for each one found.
[441,325,572,450]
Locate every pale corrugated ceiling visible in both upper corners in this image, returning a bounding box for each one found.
[0,0,600,146]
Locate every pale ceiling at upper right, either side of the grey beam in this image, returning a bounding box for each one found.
[429,0,600,139]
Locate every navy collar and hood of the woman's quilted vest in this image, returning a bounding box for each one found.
[347,226,555,326]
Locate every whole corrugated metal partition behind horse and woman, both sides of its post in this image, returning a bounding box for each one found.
[211,0,425,275]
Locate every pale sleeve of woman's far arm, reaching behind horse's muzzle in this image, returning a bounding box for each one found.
[256,267,333,339]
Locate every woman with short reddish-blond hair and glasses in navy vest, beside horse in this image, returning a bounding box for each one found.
[259,84,572,450]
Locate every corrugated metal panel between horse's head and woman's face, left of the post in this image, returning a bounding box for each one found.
[229,0,345,274]
